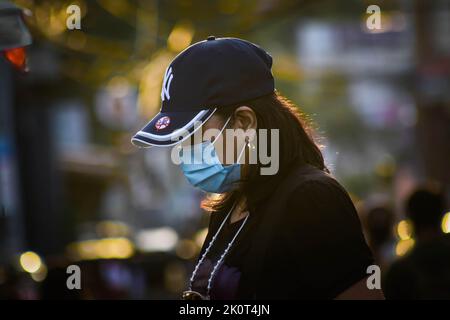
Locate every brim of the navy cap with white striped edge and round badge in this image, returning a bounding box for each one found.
[131,109,216,148]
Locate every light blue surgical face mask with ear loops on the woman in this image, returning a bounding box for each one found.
[181,118,245,193]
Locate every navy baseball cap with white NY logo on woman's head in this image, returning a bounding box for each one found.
[131,36,275,147]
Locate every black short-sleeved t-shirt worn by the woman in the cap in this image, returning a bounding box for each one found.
[194,167,373,299]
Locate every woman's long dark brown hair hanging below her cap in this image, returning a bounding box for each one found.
[202,92,328,211]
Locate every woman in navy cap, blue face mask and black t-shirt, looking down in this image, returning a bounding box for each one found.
[132,37,383,299]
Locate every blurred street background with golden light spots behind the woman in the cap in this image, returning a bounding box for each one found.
[0,0,450,299]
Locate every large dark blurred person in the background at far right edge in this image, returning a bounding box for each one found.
[384,187,450,299]
